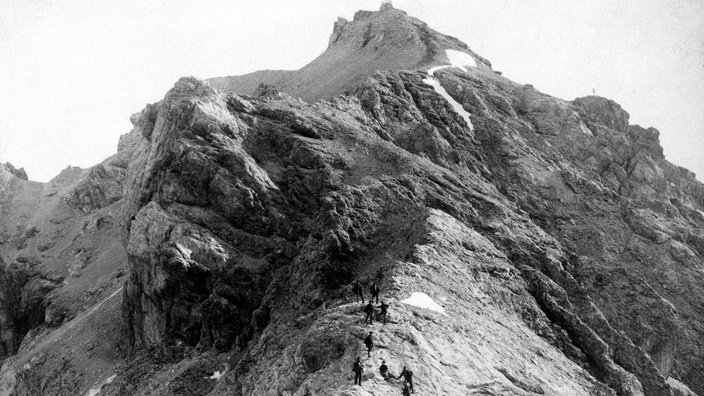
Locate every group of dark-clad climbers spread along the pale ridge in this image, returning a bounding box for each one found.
[352,280,415,396]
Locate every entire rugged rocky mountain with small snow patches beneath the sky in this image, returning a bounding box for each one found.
[0,4,704,396]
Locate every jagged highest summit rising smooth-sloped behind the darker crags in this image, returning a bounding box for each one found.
[209,3,491,101]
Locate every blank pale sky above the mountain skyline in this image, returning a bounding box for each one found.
[0,0,704,181]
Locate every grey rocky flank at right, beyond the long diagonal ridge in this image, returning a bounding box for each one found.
[424,66,702,389]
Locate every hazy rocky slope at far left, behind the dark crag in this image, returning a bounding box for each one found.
[0,130,134,394]
